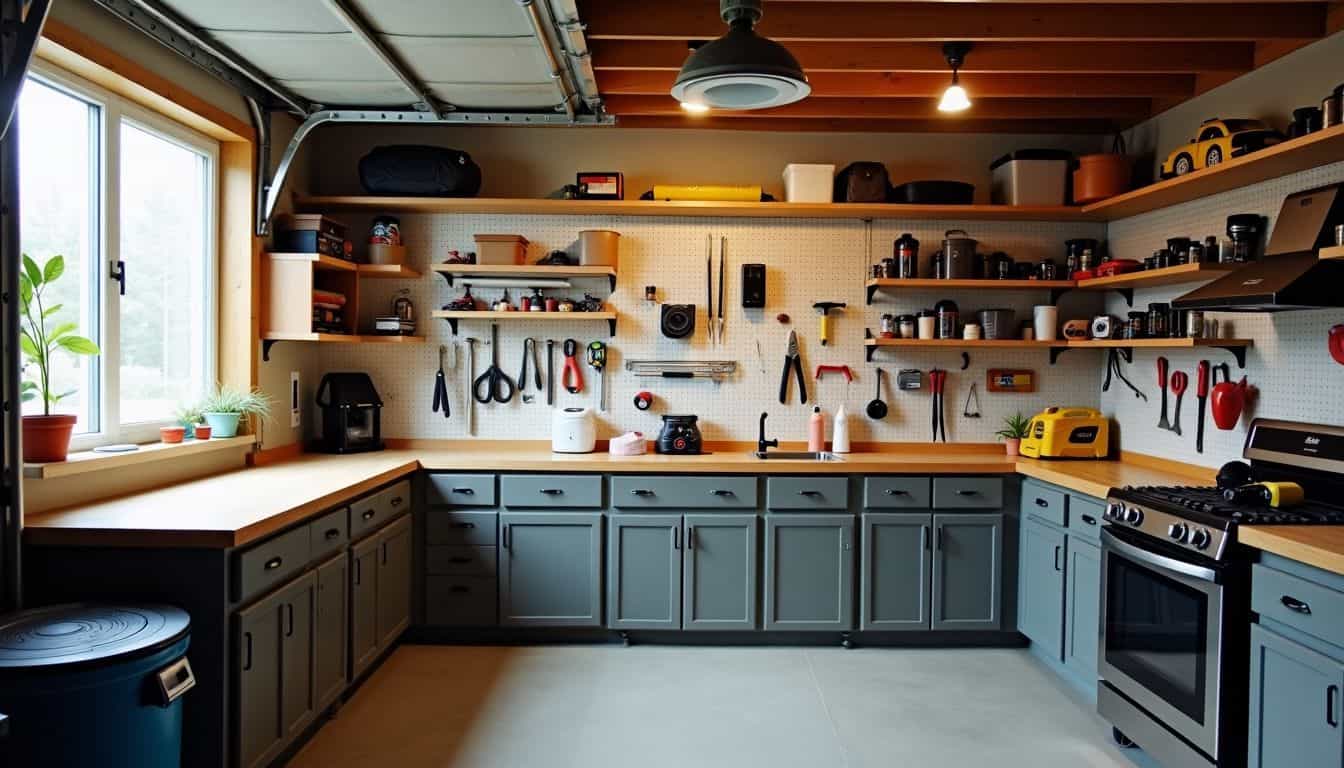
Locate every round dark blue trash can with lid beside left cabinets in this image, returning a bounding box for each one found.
[0,604,196,768]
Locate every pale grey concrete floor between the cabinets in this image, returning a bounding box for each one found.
[289,646,1155,768]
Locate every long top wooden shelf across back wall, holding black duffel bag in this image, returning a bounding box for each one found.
[297,195,1102,222]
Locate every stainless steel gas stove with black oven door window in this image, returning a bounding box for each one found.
[1097,420,1344,768]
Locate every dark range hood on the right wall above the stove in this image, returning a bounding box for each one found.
[1172,184,1344,312]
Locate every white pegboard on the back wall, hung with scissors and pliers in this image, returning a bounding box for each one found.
[309,214,1103,441]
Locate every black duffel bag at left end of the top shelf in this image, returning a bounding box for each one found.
[359,144,481,198]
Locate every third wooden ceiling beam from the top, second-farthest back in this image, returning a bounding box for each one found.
[597,70,1195,100]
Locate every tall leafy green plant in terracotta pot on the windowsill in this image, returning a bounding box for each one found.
[19,254,98,461]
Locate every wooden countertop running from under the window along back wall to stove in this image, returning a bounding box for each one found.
[24,441,1212,549]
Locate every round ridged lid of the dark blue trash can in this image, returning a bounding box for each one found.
[0,603,191,670]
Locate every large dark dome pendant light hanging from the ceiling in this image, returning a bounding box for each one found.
[672,0,812,112]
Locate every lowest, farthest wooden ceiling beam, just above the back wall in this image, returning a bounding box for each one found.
[603,95,1152,121]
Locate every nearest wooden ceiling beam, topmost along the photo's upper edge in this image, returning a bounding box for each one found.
[581,0,1328,42]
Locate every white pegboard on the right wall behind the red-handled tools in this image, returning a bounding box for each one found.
[1101,156,1344,467]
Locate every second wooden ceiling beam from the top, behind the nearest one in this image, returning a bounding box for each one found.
[590,40,1255,75]
